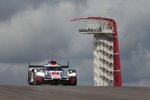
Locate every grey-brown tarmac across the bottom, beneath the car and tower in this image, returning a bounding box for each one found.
[0,85,150,100]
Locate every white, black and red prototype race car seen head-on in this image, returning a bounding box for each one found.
[28,60,77,86]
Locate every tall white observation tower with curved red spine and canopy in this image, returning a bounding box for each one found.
[71,17,122,87]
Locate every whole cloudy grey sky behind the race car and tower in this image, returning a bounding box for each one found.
[0,0,150,87]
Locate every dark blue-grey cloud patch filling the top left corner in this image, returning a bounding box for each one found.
[0,0,64,21]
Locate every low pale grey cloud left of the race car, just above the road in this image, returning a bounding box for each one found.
[0,63,28,85]
